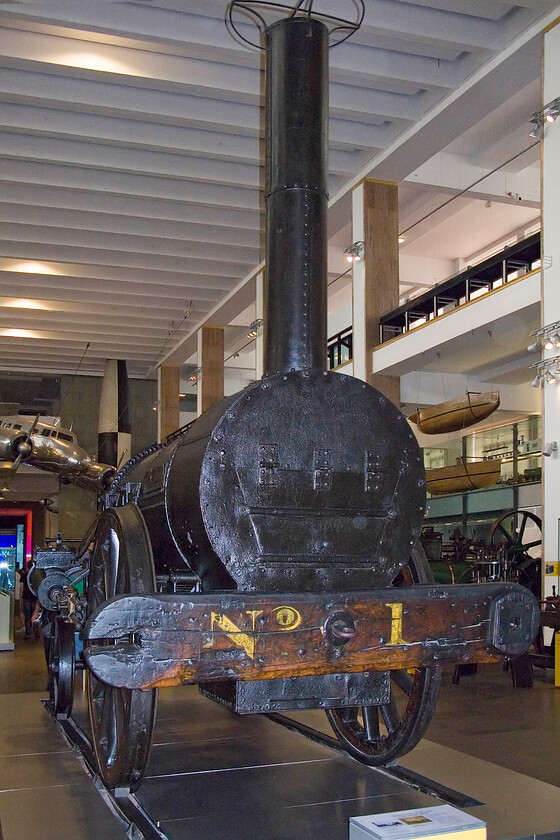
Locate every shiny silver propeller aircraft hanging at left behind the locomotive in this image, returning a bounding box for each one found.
[0,414,116,493]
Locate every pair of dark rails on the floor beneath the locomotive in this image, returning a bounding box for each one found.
[44,700,484,840]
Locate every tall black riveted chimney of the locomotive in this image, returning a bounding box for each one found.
[264,17,328,373]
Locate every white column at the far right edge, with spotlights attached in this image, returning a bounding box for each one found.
[541,19,560,595]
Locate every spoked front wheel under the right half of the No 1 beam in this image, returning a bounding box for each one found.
[327,547,441,766]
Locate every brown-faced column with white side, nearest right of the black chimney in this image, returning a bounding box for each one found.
[352,180,400,407]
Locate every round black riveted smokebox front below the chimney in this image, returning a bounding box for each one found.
[179,371,425,591]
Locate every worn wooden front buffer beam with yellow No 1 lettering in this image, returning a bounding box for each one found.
[84,583,539,700]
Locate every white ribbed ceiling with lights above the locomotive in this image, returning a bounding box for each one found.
[0,0,560,376]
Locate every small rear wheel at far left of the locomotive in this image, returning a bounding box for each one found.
[45,618,76,720]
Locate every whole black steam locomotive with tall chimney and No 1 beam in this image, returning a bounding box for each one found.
[32,0,539,790]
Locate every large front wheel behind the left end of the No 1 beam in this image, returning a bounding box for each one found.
[87,504,157,791]
